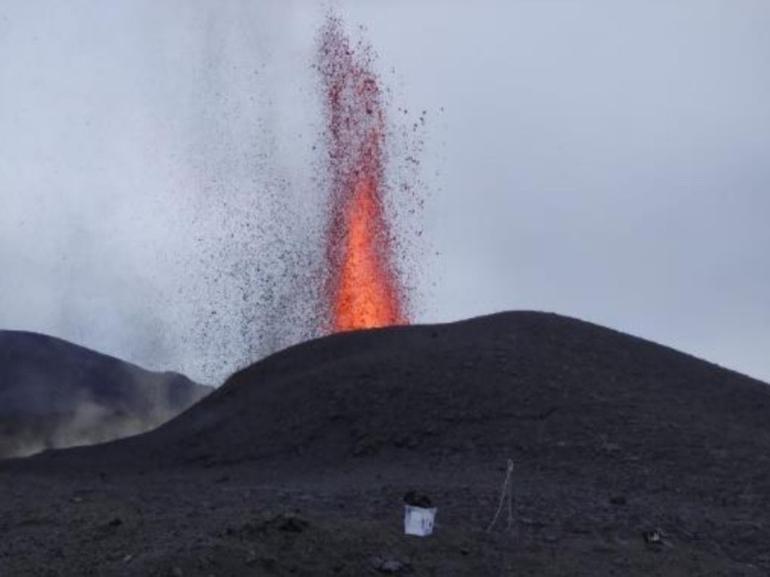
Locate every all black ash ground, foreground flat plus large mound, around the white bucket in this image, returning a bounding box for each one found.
[0,312,770,577]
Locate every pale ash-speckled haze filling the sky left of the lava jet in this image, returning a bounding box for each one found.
[0,2,332,384]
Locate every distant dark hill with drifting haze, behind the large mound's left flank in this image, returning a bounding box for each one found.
[0,331,210,458]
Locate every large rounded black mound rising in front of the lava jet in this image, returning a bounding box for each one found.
[93,312,770,485]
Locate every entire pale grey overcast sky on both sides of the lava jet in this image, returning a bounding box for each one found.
[0,0,770,382]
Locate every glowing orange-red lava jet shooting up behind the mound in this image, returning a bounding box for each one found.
[320,17,409,332]
